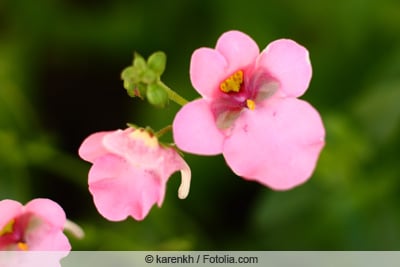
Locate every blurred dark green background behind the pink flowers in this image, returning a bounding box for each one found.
[0,0,400,250]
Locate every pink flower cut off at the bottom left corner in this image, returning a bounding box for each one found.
[0,198,71,251]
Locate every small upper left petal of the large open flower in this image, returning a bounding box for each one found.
[190,48,228,98]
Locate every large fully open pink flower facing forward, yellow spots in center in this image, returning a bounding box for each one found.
[173,31,325,190]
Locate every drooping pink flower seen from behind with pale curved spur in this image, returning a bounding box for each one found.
[79,128,191,221]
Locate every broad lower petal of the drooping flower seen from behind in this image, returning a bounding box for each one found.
[89,155,165,221]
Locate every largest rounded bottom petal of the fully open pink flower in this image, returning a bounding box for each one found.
[223,98,325,190]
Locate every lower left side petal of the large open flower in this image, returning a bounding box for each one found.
[172,99,225,155]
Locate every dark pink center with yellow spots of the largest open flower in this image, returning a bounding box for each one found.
[211,68,279,129]
